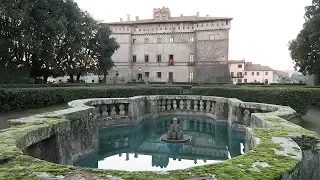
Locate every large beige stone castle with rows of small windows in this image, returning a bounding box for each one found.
[107,7,232,82]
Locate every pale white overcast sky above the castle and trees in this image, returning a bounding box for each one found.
[75,0,312,70]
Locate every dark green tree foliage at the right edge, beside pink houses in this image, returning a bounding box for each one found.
[289,0,320,83]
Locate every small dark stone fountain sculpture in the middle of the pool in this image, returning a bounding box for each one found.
[160,118,191,143]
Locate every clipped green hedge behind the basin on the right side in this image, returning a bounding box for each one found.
[191,87,320,113]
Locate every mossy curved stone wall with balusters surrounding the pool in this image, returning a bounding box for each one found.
[0,95,320,180]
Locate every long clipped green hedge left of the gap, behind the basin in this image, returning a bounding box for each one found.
[0,87,182,112]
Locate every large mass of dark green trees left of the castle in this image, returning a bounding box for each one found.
[0,0,119,83]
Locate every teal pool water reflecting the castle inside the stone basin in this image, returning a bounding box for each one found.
[74,115,245,171]
